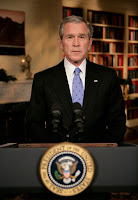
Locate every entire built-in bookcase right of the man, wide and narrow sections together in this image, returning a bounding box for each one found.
[87,10,138,126]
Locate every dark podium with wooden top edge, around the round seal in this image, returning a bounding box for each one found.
[0,143,138,193]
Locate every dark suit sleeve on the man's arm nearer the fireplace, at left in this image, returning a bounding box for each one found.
[27,74,46,142]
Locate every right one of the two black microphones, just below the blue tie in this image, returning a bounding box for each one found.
[73,102,84,133]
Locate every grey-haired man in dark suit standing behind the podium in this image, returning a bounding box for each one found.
[27,16,126,143]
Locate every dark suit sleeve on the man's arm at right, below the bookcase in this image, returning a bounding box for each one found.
[106,71,126,143]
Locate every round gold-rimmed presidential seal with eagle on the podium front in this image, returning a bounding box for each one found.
[40,142,95,196]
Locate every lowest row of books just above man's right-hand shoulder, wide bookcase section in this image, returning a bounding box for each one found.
[88,54,123,67]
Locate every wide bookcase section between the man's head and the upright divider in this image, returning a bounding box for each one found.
[87,10,124,78]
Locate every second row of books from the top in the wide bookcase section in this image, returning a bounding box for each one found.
[93,25,124,40]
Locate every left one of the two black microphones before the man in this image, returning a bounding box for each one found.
[51,104,61,133]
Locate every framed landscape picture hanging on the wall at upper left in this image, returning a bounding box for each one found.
[0,9,25,55]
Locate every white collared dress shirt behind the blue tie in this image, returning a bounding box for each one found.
[64,57,86,96]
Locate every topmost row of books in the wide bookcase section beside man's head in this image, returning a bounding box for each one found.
[87,10,124,26]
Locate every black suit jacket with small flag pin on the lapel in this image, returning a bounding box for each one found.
[27,60,126,143]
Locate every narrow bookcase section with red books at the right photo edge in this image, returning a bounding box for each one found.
[127,15,138,93]
